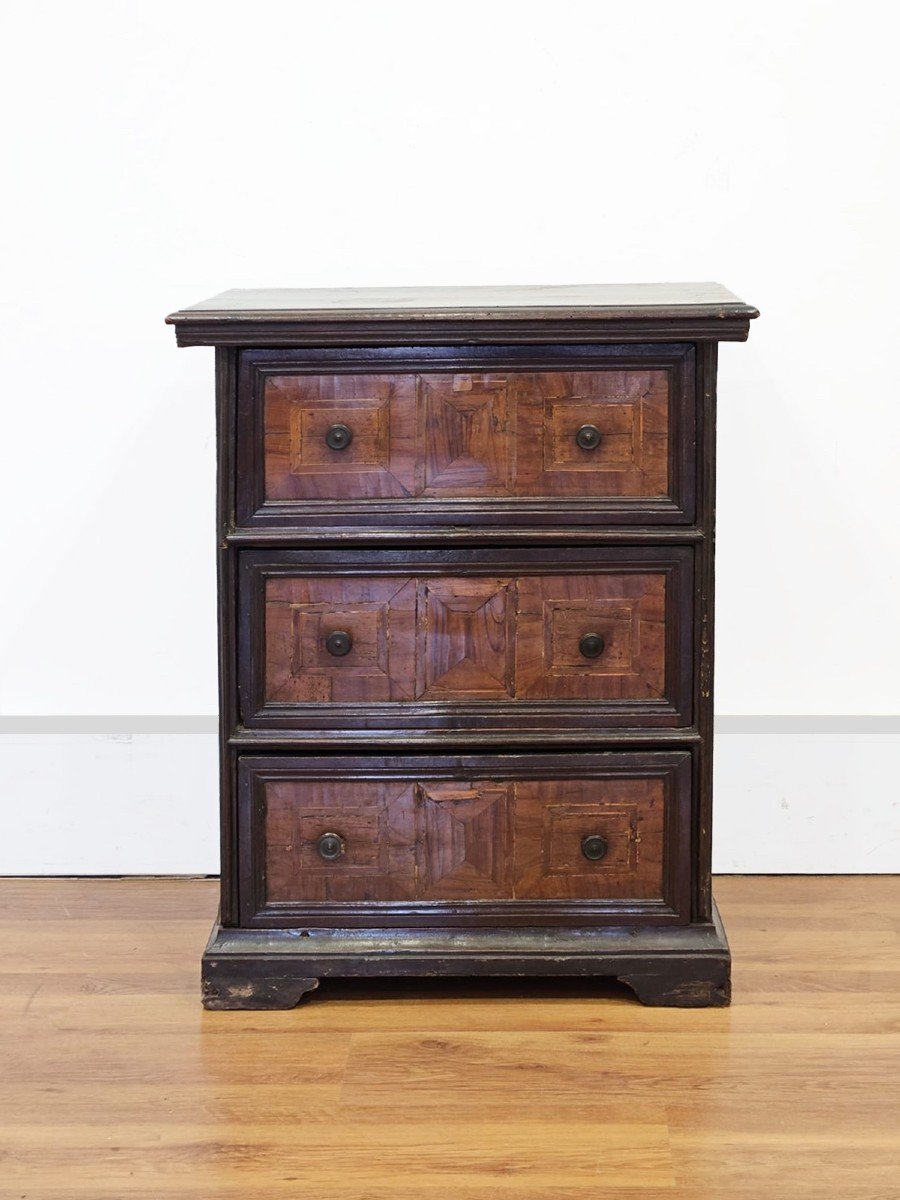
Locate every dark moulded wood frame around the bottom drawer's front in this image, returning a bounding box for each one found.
[238,750,692,929]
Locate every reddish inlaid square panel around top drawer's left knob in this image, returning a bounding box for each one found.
[263,374,416,500]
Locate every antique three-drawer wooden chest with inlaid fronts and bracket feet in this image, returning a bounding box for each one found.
[168,284,757,1008]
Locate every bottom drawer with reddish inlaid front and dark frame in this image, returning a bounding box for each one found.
[238,750,691,926]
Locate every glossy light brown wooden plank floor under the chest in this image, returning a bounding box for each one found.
[0,877,900,1200]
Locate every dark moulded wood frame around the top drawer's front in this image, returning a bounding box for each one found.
[236,343,696,523]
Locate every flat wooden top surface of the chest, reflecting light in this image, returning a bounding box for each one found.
[166,283,758,325]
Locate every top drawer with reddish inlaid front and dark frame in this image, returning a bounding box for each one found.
[238,346,695,524]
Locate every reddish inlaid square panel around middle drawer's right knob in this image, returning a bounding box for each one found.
[516,572,666,700]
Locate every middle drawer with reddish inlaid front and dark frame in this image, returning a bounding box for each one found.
[239,547,692,730]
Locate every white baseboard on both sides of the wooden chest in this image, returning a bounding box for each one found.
[0,716,900,875]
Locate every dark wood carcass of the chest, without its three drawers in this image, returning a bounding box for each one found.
[195,290,734,1008]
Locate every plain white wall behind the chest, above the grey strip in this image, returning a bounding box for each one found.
[0,0,900,869]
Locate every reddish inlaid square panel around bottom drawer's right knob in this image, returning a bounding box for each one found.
[515,778,665,900]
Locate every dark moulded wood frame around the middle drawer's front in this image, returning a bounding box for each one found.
[238,546,694,738]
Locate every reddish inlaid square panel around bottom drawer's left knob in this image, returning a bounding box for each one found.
[257,779,415,904]
